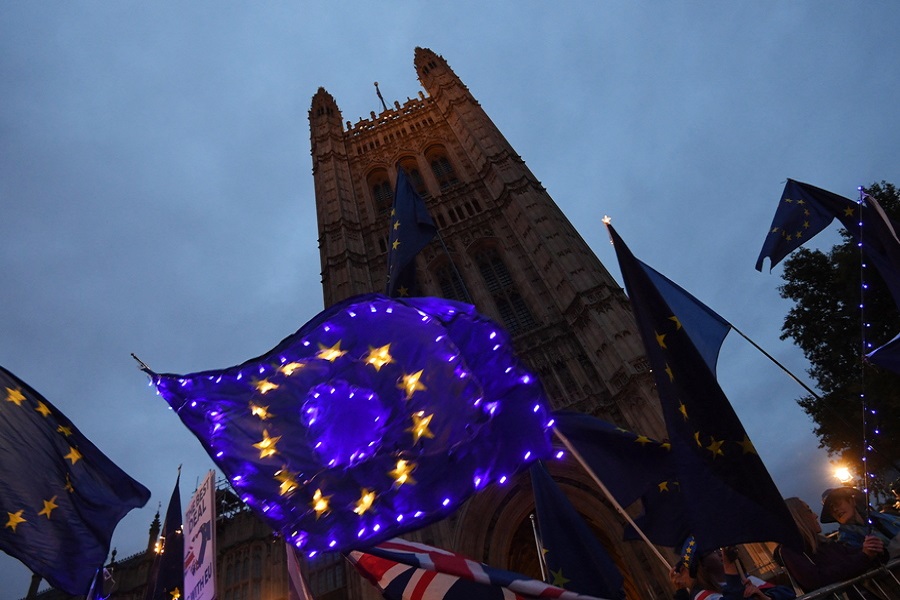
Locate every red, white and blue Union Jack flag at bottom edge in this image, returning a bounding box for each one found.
[348,538,597,600]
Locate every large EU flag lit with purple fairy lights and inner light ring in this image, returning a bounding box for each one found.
[144,294,551,553]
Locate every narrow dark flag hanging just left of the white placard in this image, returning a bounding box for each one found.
[144,469,184,600]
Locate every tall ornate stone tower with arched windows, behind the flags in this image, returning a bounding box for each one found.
[309,48,669,598]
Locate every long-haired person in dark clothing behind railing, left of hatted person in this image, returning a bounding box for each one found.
[775,498,884,592]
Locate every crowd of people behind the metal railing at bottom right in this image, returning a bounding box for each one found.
[669,480,900,600]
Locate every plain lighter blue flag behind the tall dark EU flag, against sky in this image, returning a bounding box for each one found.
[637,260,732,373]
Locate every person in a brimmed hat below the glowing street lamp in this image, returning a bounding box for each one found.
[822,487,900,559]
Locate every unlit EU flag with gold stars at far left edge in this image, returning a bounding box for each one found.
[0,367,150,596]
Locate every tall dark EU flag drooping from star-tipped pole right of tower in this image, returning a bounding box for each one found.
[607,225,799,552]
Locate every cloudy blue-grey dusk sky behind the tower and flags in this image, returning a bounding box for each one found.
[0,0,900,598]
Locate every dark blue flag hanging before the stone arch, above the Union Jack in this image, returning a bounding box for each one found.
[531,462,625,598]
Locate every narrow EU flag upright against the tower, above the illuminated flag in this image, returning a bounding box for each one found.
[385,169,437,297]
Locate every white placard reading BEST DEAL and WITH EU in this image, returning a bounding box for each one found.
[183,471,216,600]
